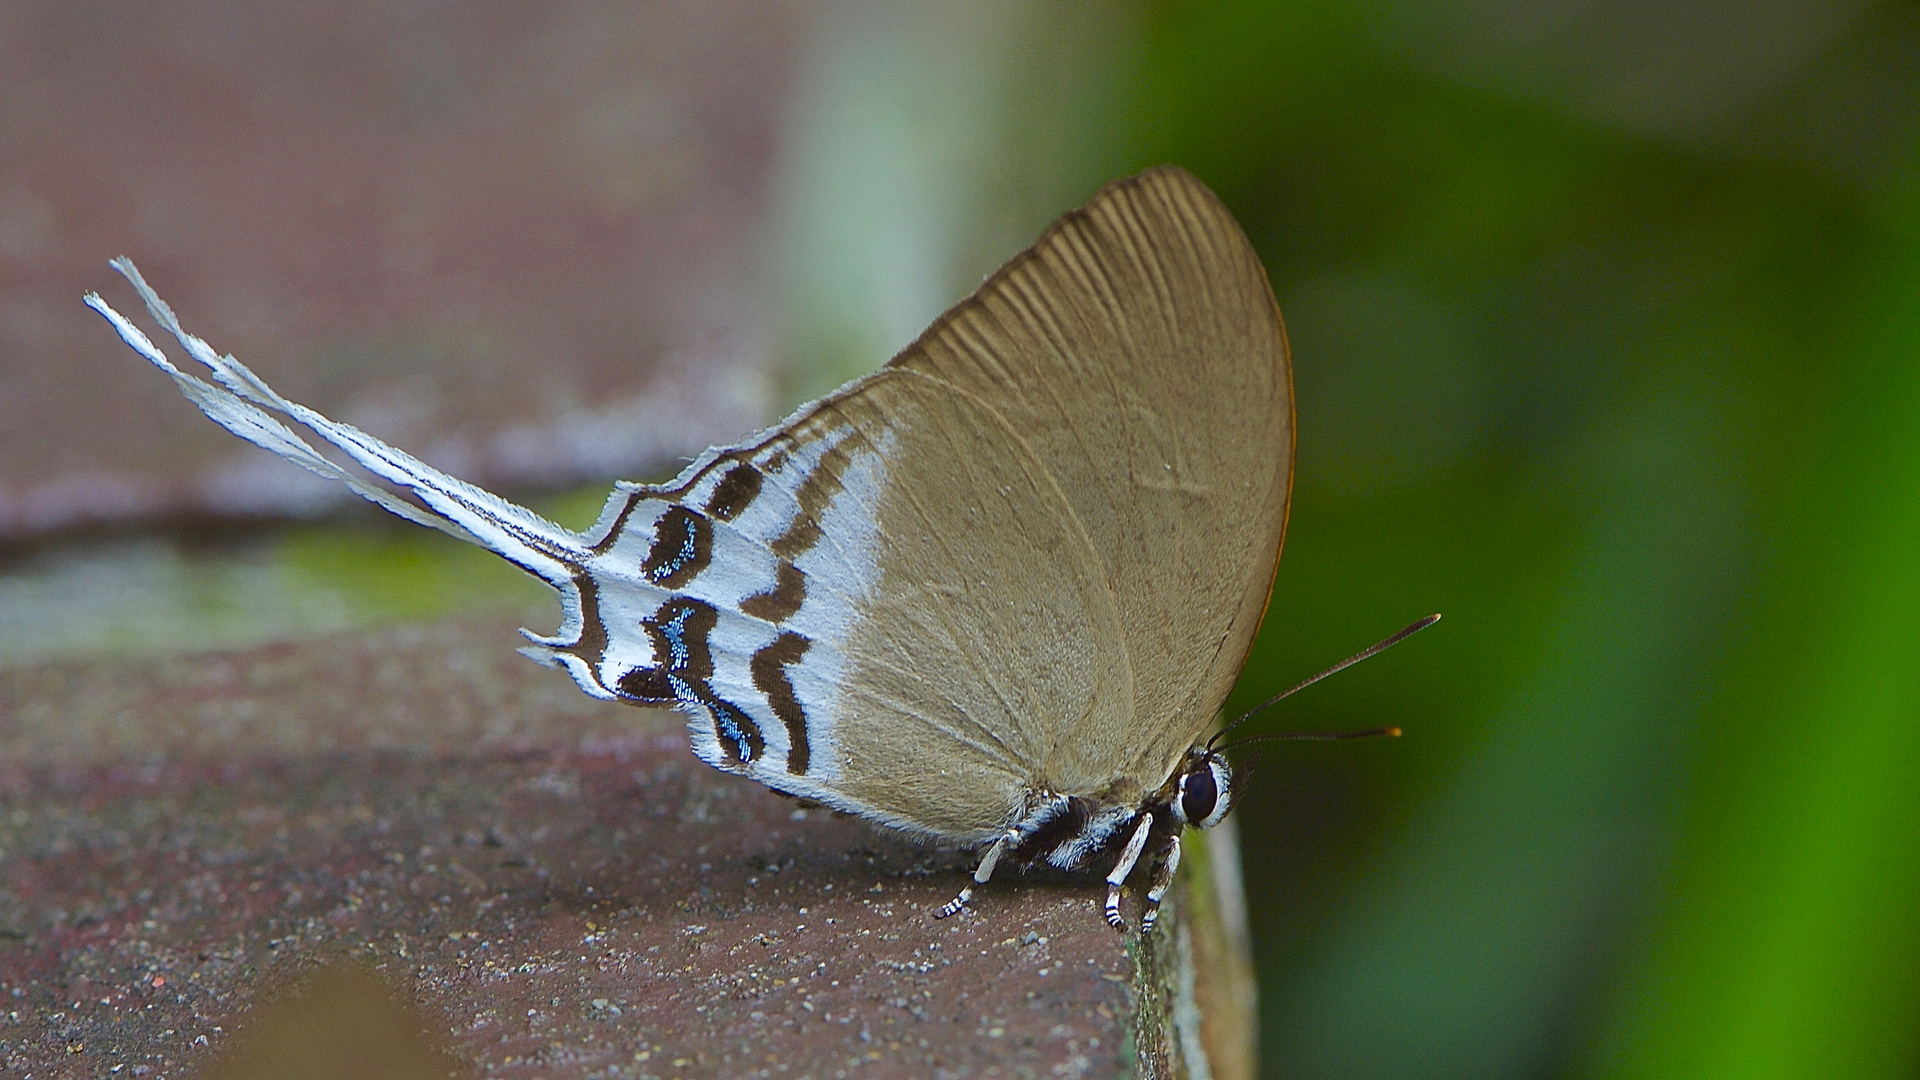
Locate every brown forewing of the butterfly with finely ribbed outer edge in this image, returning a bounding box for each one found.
[889,167,1294,792]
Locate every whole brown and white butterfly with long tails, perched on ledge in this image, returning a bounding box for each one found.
[86,167,1419,930]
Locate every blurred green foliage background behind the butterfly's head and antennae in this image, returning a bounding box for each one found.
[8,0,1920,1078]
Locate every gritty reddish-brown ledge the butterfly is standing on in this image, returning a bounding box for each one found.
[0,617,1250,1076]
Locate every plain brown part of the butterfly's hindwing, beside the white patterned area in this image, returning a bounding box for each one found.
[798,367,1133,842]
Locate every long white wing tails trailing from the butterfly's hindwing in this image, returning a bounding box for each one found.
[86,256,589,599]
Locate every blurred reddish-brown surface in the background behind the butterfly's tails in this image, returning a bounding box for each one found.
[0,0,806,538]
